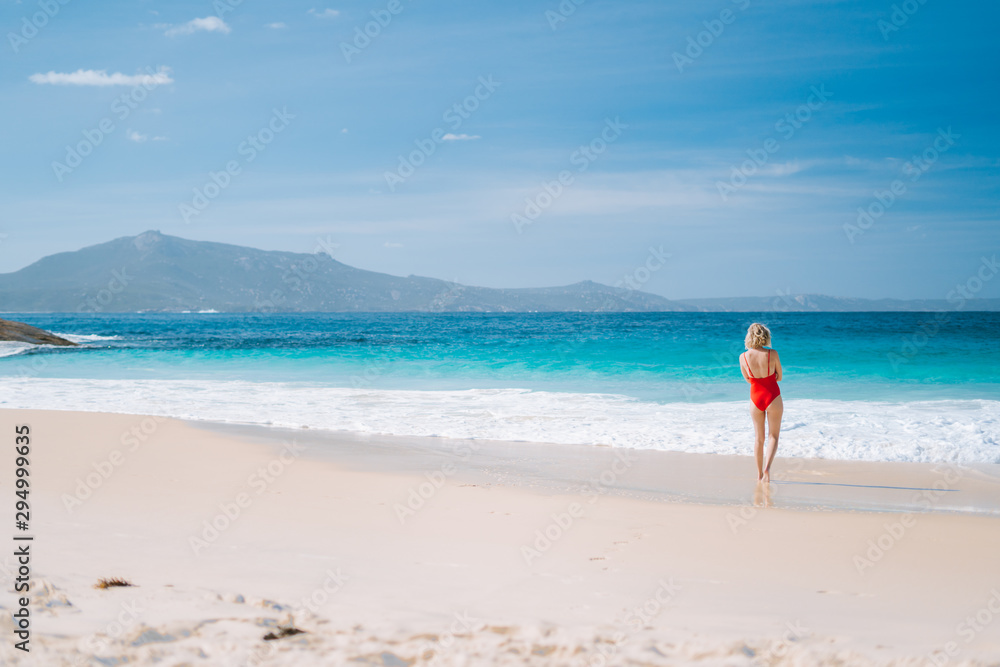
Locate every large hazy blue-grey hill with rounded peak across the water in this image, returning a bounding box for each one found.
[0,231,694,312]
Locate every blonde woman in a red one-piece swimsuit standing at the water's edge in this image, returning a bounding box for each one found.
[740,322,784,482]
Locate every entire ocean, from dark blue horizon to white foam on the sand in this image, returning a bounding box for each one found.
[0,312,1000,463]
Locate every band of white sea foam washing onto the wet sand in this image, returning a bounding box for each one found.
[0,378,1000,464]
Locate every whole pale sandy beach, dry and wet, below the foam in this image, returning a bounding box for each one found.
[0,410,1000,665]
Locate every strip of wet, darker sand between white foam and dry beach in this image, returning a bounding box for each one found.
[195,420,1000,516]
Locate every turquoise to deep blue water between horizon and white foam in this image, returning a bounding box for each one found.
[0,313,1000,403]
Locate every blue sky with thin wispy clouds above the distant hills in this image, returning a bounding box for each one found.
[0,0,1000,298]
